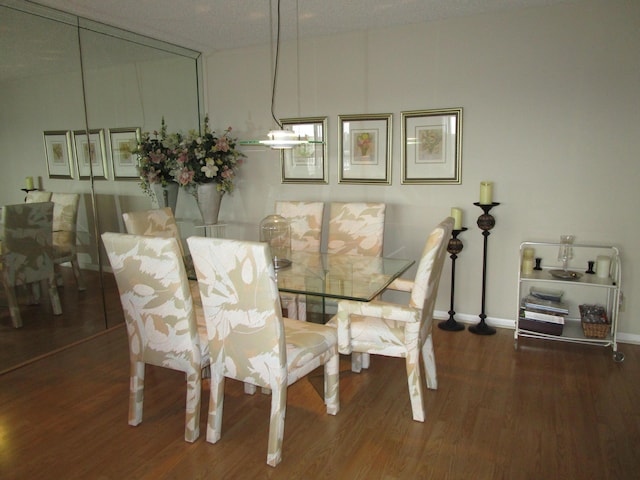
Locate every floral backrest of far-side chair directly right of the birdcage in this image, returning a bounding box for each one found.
[276,201,324,252]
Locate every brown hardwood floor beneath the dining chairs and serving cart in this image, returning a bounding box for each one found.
[0,310,640,480]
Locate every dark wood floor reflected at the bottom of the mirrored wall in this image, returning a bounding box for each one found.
[0,267,124,372]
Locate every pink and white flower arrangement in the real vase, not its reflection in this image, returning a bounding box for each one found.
[173,117,245,193]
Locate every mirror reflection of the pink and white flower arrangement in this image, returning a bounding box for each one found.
[136,117,183,195]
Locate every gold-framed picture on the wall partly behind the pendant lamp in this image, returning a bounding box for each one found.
[280,117,328,184]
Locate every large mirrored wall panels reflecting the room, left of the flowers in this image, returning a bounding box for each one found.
[0,0,202,372]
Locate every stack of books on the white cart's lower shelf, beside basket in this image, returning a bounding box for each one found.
[519,292,569,335]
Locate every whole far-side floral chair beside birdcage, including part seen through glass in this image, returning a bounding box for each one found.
[276,201,324,320]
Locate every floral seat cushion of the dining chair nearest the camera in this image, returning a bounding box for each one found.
[283,318,338,371]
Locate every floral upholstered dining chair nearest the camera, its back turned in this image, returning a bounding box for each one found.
[187,237,340,466]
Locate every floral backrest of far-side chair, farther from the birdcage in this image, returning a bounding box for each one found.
[327,202,386,256]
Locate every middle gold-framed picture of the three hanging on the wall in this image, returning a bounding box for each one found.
[338,113,392,185]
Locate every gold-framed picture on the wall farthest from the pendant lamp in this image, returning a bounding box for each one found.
[401,108,462,184]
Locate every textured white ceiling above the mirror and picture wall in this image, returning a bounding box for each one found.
[33,0,581,52]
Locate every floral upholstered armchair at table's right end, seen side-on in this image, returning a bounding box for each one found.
[330,217,453,422]
